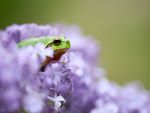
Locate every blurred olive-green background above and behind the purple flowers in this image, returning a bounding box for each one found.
[0,0,150,88]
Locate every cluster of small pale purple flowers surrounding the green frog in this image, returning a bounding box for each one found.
[0,24,150,113]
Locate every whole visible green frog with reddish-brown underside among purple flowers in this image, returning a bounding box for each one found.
[17,36,70,71]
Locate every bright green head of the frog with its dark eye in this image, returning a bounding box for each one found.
[47,36,70,51]
